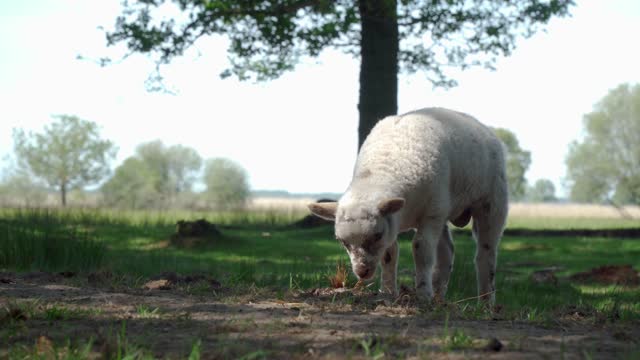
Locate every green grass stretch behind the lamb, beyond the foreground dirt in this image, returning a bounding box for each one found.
[0,210,640,322]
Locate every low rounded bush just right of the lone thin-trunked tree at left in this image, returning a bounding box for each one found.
[101,157,162,209]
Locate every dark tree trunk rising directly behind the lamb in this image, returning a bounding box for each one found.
[358,0,400,149]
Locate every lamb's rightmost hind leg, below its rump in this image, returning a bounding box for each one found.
[473,202,507,303]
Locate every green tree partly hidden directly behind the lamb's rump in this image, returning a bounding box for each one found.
[493,128,531,200]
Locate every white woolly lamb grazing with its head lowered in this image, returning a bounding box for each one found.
[309,108,508,302]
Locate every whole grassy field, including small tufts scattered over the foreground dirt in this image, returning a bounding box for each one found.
[0,209,640,358]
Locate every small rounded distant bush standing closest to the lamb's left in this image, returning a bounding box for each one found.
[204,158,251,209]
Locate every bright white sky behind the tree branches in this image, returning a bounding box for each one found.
[0,0,640,194]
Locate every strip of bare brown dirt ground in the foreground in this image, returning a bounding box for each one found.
[0,273,640,359]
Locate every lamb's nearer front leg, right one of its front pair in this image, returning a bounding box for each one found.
[413,221,444,299]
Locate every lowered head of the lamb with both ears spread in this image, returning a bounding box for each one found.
[309,198,405,280]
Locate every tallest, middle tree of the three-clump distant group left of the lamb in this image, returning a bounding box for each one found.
[136,140,202,200]
